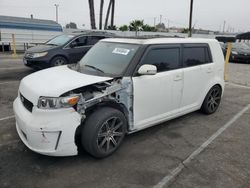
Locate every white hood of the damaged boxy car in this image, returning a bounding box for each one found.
[19,65,112,105]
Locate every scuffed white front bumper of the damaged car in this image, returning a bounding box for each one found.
[13,97,81,156]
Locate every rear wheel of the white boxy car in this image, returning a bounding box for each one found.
[201,85,222,114]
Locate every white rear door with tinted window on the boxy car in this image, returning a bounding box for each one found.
[181,44,214,111]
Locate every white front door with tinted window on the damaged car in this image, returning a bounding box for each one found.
[133,45,183,130]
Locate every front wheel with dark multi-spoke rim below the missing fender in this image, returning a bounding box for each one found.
[81,107,127,158]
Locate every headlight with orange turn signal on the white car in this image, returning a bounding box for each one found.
[37,95,80,109]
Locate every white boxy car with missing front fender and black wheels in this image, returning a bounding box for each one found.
[14,38,224,158]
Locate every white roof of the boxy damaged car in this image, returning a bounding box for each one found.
[102,38,217,45]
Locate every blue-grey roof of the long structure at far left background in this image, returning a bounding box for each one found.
[0,15,62,31]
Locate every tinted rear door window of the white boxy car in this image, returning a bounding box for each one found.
[183,46,212,67]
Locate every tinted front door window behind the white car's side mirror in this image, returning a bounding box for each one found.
[142,48,180,72]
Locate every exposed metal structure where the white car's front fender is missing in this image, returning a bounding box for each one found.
[64,77,133,131]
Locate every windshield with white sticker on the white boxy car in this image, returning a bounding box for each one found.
[80,42,140,76]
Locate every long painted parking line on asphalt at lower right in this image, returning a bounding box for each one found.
[154,104,250,188]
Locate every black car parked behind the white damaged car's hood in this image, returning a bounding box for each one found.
[23,32,114,69]
